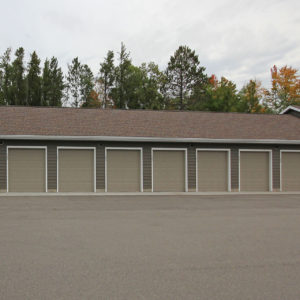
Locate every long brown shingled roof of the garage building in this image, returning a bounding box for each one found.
[0,106,300,140]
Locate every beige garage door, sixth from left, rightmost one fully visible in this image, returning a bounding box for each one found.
[240,151,270,192]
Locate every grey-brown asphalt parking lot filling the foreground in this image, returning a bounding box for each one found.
[0,195,300,300]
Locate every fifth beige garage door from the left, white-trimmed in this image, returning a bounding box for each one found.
[197,151,228,192]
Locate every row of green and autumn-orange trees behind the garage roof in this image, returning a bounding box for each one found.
[0,43,300,113]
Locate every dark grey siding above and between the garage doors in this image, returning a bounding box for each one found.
[0,140,300,192]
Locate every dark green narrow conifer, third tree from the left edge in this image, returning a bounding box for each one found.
[26,51,43,106]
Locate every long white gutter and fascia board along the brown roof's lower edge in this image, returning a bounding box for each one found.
[0,135,300,145]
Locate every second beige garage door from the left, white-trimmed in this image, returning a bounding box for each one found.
[58,149,95,192]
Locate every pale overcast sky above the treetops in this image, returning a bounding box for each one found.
[0,0,300,87]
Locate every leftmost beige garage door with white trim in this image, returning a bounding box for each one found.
[8,149,46,192]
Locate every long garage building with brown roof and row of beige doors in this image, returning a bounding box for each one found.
[0,106,300,193]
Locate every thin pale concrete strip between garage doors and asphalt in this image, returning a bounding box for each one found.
[0,191,300,197]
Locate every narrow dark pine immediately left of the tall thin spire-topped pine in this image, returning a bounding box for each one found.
[99,51,115,108]
